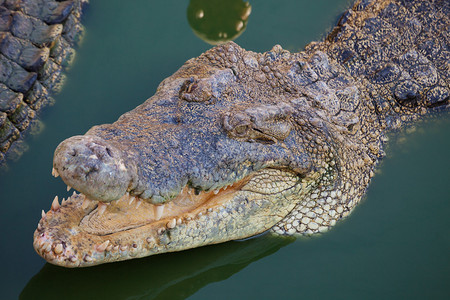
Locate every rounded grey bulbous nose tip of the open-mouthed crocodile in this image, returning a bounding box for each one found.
[53,135,135,202]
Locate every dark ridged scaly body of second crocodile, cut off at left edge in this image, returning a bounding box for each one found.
[0,0,87,166]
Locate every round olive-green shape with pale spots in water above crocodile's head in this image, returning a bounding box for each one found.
[187,0,252,45]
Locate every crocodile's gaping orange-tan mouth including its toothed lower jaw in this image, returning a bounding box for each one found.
[34,169,299,267]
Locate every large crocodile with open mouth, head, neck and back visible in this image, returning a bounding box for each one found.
[33,0,450,267]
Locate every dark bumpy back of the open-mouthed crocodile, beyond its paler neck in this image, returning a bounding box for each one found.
[314,0,450,129]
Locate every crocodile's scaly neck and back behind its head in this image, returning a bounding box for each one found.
[266,0,450,234]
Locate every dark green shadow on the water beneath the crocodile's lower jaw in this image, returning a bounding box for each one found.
[19,234,294,299]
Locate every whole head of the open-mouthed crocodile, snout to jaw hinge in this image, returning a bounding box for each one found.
[34,43,342,267]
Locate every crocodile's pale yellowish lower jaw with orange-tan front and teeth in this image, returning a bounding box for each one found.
[34,169,305,267]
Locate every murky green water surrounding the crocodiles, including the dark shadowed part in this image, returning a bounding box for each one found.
[0,0,450,299]
